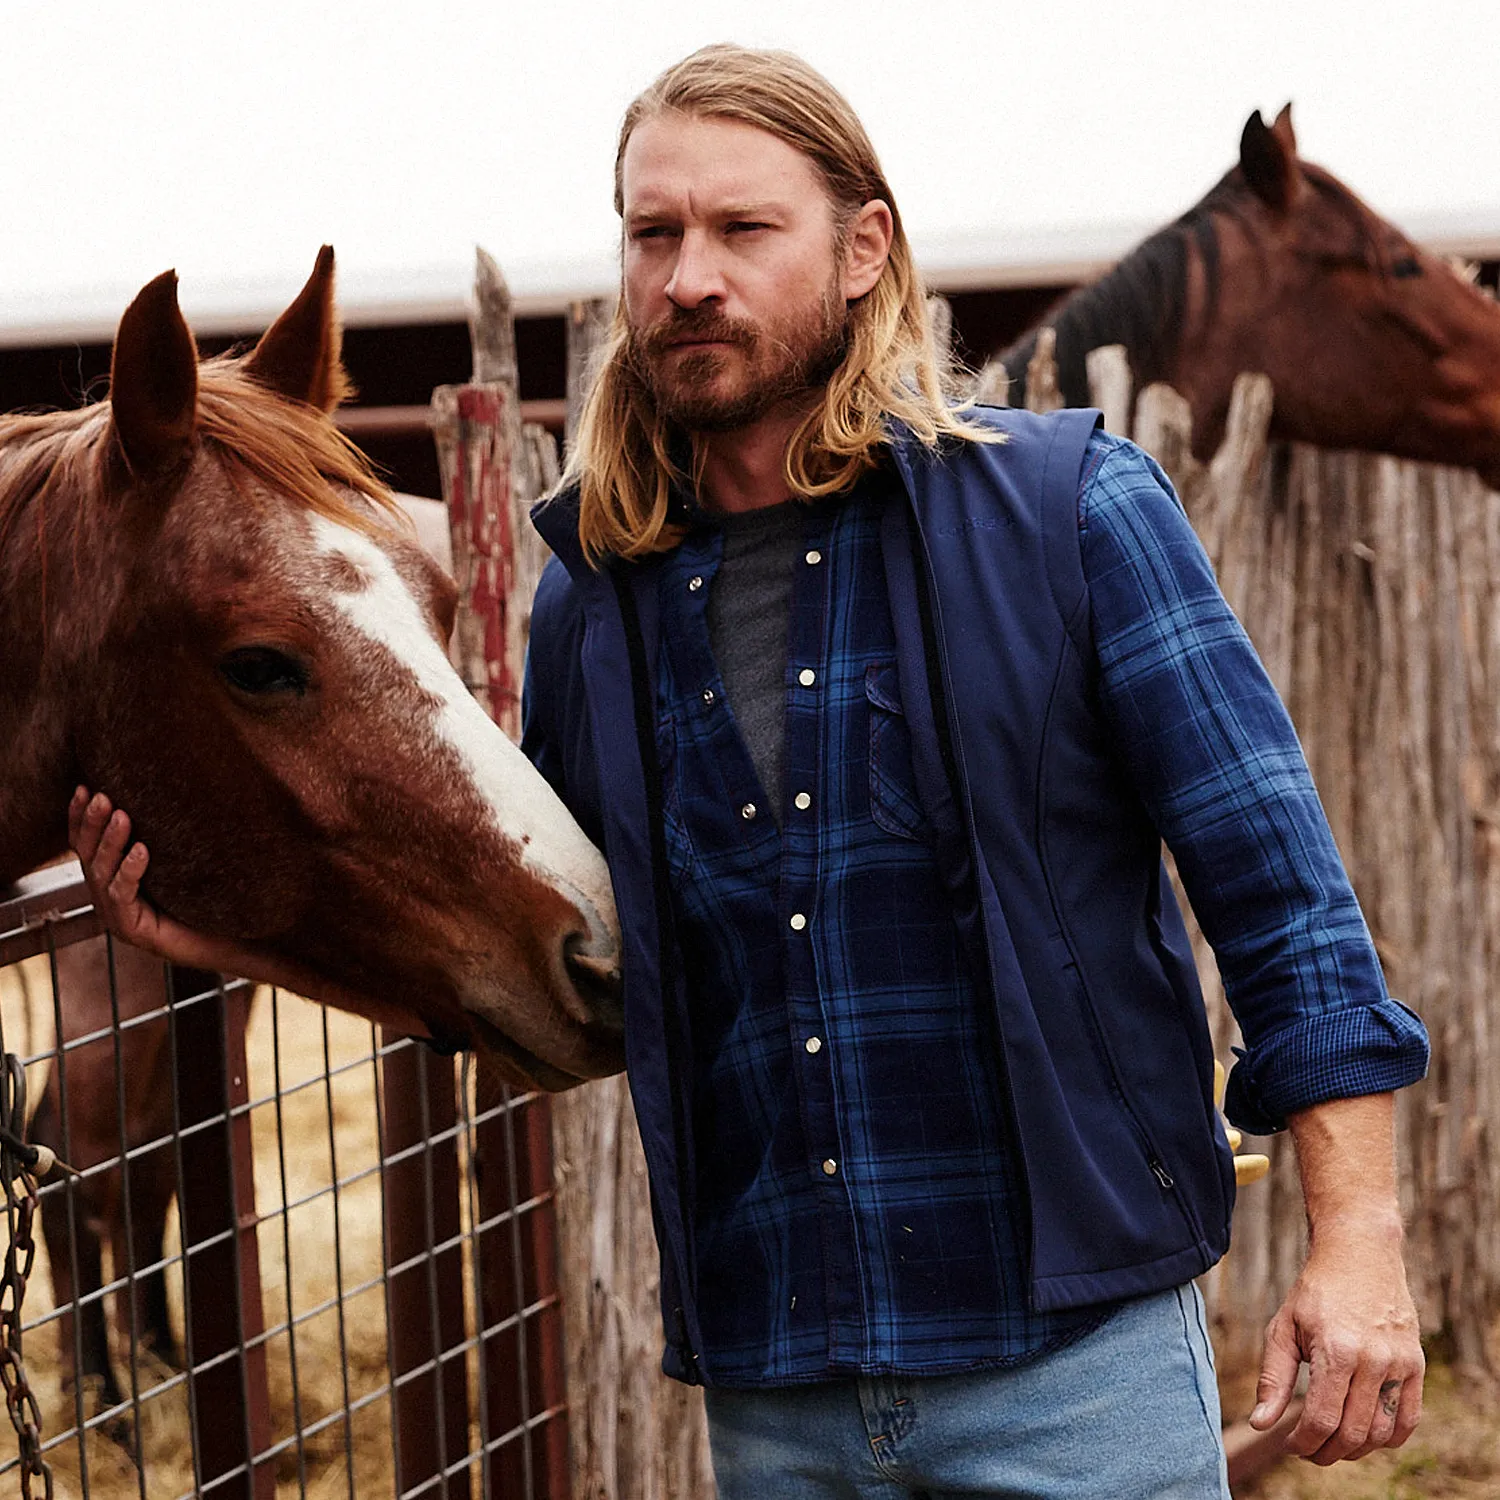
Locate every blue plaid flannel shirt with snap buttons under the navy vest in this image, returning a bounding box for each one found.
[659,435,1425,1386]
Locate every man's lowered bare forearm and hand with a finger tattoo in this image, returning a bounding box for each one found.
[1250,1095,1427,1464]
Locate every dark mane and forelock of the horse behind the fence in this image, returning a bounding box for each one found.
[1001,162,1373,407]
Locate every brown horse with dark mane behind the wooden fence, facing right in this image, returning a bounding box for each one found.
[987,105,1500,488]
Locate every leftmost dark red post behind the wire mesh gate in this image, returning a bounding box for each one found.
[171,965,276,1500]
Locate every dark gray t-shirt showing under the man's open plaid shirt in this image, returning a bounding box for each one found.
[708,500,807,827]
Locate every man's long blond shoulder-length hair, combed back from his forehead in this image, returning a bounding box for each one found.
[567,45,999,564]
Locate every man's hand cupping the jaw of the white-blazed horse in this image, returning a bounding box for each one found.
[68,786,239,972]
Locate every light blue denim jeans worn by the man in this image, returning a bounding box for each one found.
[705,1283,1229,1500]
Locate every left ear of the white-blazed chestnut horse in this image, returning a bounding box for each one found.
[110,272,198,479]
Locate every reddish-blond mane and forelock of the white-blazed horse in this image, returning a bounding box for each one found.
[0,354,401,548]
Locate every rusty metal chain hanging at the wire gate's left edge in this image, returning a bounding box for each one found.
[0,1052,53,1500]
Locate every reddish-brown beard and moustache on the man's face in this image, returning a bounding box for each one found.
[626,285,849,432]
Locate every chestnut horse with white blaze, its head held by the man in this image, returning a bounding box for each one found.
[0,248,621,1089]
